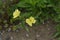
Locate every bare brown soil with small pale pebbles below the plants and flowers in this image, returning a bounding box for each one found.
[2,21,56,40]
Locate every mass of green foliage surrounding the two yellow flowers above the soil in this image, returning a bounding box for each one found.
[0,0,60,30]
